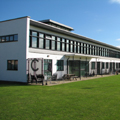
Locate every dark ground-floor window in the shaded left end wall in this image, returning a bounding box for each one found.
[7,60,18,70]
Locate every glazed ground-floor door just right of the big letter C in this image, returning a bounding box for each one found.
[44,59,52,77]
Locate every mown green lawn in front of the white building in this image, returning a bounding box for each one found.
[0,75,120,120]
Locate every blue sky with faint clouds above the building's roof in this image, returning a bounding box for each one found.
[0,0,120,47]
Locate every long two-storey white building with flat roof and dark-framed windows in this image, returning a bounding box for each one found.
[0,16,120,82]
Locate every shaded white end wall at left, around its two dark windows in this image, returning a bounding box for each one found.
[0,17,29,82]
